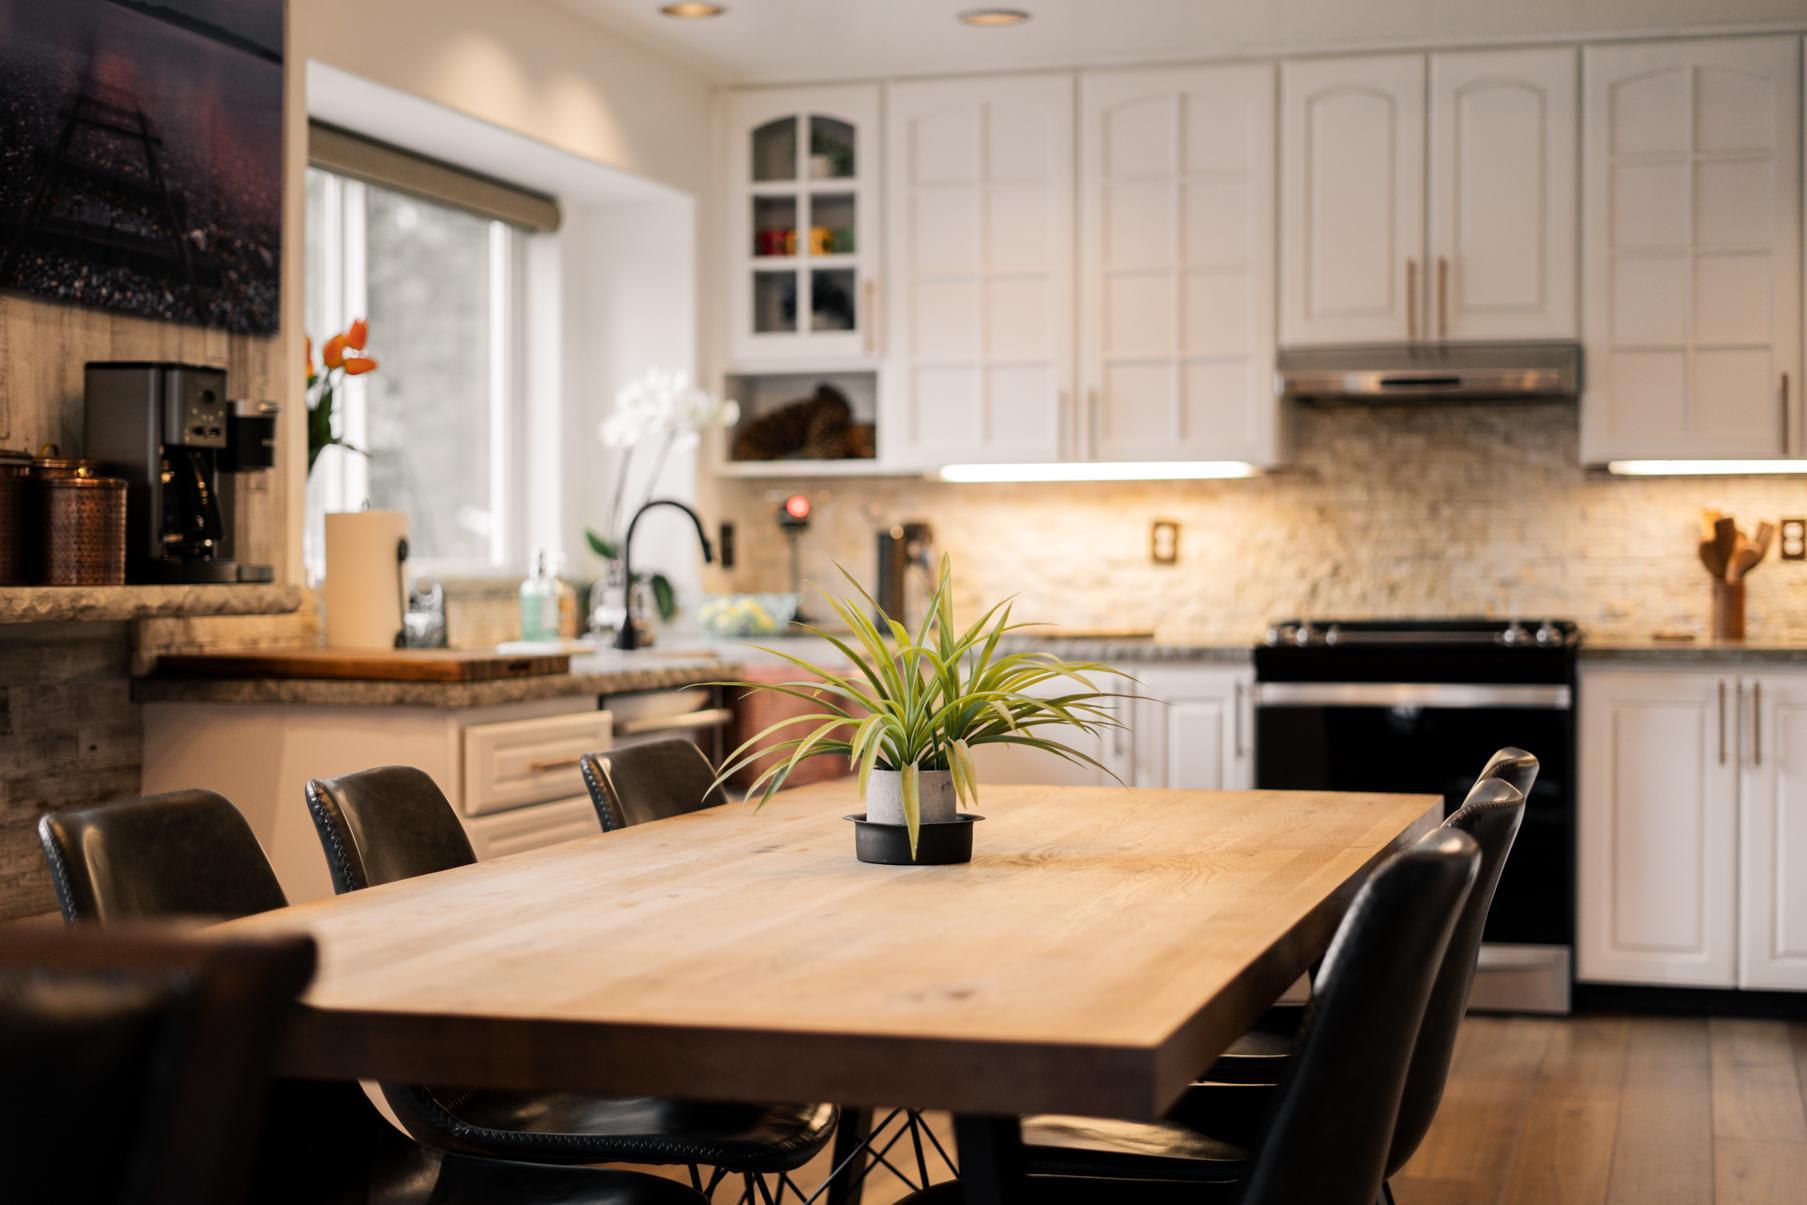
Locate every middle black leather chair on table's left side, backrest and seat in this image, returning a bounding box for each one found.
[307,766,837,1201]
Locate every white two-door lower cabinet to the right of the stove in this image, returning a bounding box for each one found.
[1576,665,1807,990]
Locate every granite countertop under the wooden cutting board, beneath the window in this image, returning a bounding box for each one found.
[132,649,741,708]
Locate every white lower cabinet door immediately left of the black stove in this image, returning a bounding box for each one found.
[1133,665,1254,791]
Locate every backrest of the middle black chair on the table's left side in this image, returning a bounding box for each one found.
[307,766,477,894]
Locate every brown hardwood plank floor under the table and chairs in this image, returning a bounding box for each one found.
[643,1017,1807,1205]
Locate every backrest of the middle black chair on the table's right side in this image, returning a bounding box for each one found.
[1386,773,1538,1178]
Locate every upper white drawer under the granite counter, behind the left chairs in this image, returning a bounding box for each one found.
[463,712,611,817]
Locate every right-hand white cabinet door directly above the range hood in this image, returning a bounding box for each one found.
[1424,49,1579,340]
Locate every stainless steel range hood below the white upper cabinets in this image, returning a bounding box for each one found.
[1278,343,1581,403]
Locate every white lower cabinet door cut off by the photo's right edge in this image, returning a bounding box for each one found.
[1738,674,1807,990]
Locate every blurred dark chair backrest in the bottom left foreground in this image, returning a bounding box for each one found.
[0,925,314,1205]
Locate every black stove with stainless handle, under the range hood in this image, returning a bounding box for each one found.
[1254,620,1581,1012]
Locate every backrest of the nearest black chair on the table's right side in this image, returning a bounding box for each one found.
[1240,829,1480,1205]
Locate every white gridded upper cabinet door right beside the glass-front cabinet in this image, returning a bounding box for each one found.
[882,74,1073,466]
